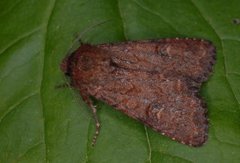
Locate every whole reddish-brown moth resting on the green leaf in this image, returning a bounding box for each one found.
[61,38,215,146]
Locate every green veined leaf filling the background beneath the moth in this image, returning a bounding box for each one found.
[0,0,240,163]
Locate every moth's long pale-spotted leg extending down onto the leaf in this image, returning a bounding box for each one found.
[84,96,100,146]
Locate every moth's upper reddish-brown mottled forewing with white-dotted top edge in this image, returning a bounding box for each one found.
[98,39,216,82]
